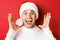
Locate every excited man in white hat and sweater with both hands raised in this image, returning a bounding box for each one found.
[5,2,56,40]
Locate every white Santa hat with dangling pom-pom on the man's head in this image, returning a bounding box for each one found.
[16,2,38,26]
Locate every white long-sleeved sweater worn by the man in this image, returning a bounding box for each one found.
[5,26,56,40]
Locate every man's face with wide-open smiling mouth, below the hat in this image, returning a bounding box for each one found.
[22,9,37,28]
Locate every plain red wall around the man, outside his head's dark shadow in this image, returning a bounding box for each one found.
[0,0,60,40]
